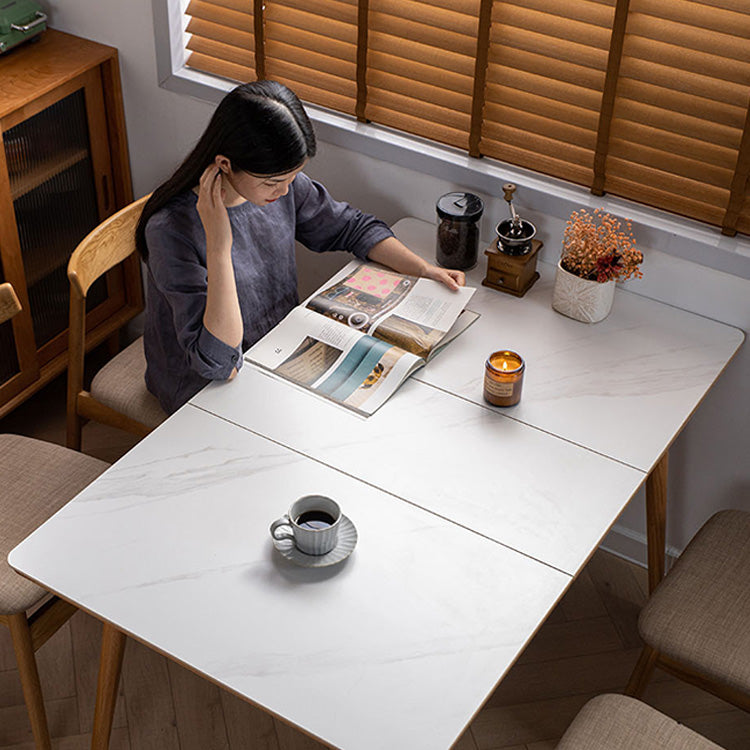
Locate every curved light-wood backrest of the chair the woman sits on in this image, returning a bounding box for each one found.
[68,195,150,297]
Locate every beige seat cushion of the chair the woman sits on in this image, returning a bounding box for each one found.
[91,336,167,427]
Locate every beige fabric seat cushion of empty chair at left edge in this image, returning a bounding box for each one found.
[0,435,108,615]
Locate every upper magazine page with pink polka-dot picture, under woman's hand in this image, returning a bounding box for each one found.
[306,262,474,359]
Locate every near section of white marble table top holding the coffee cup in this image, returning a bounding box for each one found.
[9,406,571,750]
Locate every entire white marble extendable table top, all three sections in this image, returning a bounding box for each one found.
[9,219,742,750]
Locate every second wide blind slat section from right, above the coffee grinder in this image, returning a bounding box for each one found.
[480,0,614,185]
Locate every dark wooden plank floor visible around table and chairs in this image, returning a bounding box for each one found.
[0,374,750,750]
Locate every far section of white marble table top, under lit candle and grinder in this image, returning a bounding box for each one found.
[393,218,744,472]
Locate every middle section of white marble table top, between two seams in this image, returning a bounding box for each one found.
[191,368,645,574]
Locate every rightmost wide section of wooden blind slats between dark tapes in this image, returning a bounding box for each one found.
[604,0,750,232]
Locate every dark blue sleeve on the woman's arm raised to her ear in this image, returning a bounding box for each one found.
[146,223,242,380]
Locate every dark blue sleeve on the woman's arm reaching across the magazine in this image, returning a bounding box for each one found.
[293,173,393,260]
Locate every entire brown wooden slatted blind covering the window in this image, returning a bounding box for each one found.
[182,0,750,234]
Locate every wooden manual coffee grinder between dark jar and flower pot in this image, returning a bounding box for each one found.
[482,182,542,297]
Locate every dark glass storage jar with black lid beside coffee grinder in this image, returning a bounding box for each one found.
[435,192,484,271]
